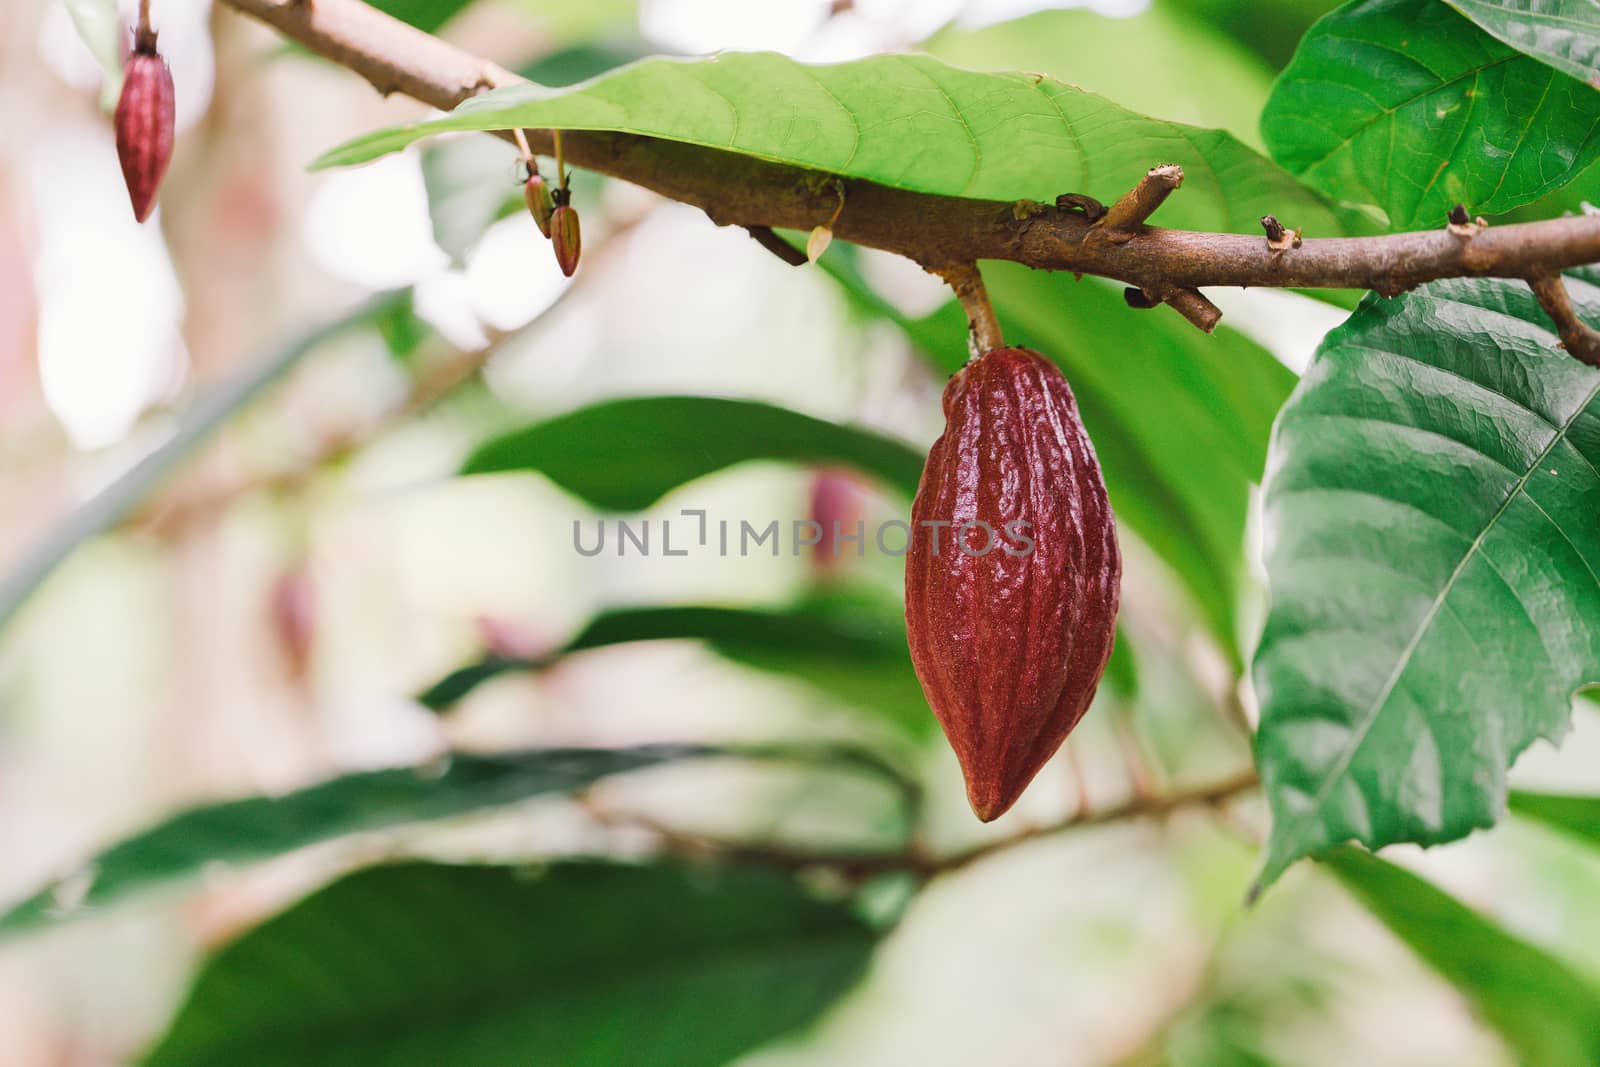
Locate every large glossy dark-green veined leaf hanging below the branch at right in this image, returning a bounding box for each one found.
[1254,273,1600,881]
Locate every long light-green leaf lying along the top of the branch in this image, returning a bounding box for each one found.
[317,53,1341,234]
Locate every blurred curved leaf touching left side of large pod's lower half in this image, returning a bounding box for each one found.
[418,601,934,736]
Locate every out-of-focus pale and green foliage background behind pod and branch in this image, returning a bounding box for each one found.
[0,0,1600,1067]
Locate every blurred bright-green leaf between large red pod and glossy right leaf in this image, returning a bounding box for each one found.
[984,264,1294,662]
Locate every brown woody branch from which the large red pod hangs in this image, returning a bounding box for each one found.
[224,0,1600,342]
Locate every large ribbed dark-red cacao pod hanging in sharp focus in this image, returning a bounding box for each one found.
[906,349,1122,822]
